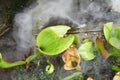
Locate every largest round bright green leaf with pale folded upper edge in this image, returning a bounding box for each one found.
[36,25,74,55]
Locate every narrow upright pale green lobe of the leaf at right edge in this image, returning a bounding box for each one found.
[103,22,113,41]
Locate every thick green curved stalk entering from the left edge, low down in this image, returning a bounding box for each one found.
[0,53,26,68]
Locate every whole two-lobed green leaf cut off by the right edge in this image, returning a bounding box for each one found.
[103,22,120,49]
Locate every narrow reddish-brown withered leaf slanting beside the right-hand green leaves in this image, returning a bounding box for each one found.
[96,37,109,59]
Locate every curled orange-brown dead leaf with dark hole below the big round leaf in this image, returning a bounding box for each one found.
[62,47,80,70]
